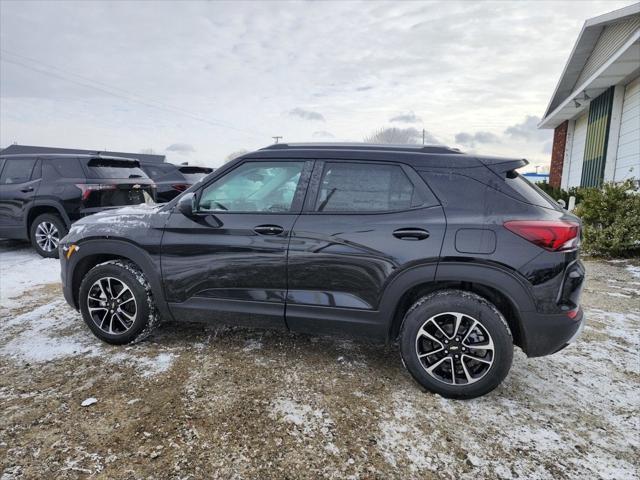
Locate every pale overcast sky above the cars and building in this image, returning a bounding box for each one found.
[0,0,633,166]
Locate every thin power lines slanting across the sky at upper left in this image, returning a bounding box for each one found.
[0,49,268,142]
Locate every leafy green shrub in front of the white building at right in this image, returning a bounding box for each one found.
[574,180,640,257]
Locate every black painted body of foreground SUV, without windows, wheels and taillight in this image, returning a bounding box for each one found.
[58,148,584,356]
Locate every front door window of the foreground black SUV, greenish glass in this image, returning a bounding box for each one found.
[199,162,304,212]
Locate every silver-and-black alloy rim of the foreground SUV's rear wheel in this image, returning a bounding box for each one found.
[416,312,495,385]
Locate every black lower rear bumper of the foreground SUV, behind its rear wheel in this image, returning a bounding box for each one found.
[522,307,585,357]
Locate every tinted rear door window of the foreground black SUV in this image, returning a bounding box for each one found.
[316,163,423,212]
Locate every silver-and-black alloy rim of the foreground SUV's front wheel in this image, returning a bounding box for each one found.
[87,277,138,335]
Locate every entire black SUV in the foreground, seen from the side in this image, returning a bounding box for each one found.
[61,144,584,398]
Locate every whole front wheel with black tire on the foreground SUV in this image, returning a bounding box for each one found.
[78,260,159,345]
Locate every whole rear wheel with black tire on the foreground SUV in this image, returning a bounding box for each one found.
[400,290,513,399]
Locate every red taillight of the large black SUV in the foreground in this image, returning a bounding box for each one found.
[504,220,580,252]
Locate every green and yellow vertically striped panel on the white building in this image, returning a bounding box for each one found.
[580,87,614,187]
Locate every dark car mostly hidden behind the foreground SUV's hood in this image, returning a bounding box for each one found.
[140,163,213,203]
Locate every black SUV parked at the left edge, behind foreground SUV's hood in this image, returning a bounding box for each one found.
[0,154,155,257]
